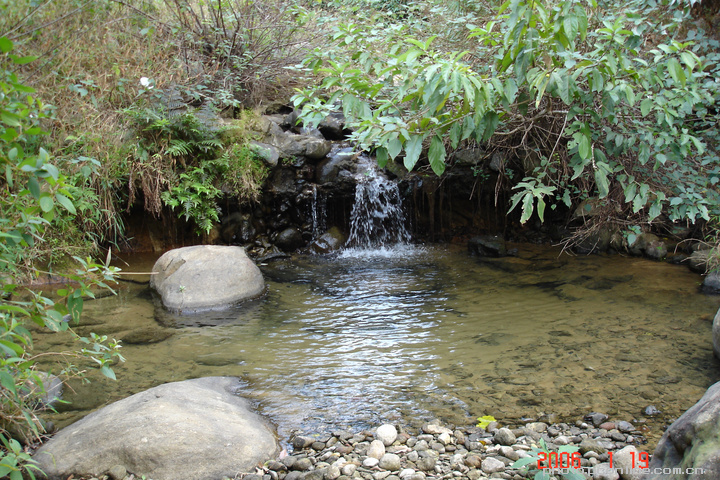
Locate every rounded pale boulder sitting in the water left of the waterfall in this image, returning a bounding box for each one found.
[150,245,265,313]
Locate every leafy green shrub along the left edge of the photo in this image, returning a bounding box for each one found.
[0,37,122,480]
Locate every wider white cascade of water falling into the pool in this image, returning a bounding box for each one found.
[347,155,410,249]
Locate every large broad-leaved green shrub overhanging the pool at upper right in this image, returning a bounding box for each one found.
[294,0,720,244]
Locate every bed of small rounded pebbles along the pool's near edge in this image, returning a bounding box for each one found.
[258,413,646,480]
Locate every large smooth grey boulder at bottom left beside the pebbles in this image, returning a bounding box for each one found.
[34,377,278,480]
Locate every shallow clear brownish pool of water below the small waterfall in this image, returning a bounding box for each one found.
[37,245,720,448]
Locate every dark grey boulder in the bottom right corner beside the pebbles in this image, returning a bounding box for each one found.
[642,382,720,480]
